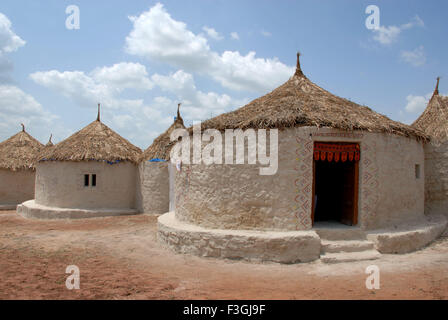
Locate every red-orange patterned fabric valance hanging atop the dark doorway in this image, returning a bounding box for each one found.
[314,142,361,162]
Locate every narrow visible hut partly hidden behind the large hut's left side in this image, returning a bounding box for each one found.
[137,104,185,214]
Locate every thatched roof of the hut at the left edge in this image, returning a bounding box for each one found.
[0,124,44,171]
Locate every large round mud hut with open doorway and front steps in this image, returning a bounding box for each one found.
[158,54,446,263]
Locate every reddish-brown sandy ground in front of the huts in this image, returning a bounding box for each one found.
[0,211,448,299]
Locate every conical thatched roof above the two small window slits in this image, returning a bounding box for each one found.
[39,107,142,163]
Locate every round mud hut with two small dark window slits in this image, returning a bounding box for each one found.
[17,107,141,219]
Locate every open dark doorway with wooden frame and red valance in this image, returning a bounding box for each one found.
[312,142,360,225]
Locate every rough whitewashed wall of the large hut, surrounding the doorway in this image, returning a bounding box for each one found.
[175,127,424,230]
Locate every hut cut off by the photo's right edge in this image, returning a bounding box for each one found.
[412,78,448,217]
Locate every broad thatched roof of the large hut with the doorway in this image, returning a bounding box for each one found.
[196,54,427,140]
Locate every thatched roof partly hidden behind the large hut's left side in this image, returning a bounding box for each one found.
[141,103,185,161]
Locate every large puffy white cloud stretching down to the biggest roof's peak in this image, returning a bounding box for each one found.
[125,3,294,93]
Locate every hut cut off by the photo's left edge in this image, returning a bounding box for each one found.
[0,124,43,210]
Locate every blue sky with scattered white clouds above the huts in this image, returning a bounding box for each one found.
[0,0,448,149]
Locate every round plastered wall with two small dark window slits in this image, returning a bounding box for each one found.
[35,161,137,209]
